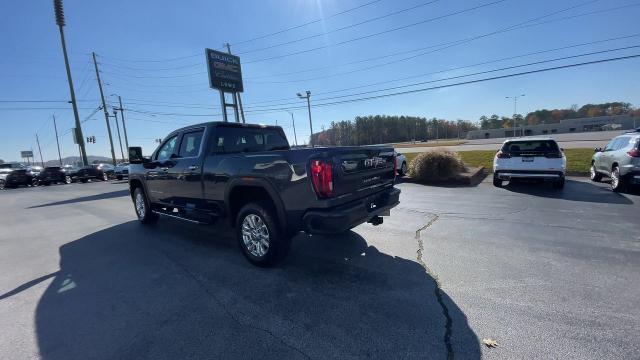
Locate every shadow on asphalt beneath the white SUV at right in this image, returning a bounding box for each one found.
[504,179,633,205]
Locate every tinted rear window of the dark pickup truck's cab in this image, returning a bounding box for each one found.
[212,126,289,154]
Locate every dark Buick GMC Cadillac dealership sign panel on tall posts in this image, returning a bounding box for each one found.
[205,49,243,93]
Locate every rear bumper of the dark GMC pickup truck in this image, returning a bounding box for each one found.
[302,187,400,234]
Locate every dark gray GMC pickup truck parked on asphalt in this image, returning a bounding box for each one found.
[129,122,400,266]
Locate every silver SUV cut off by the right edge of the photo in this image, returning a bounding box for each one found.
[590,128,640,191]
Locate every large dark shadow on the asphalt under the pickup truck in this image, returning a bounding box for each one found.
[35,219,481,359]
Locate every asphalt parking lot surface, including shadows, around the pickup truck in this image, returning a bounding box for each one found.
[0,179,640,359]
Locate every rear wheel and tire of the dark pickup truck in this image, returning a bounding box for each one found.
[236,202,291,267]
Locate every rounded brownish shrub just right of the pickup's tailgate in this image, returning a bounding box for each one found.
[409,149,465,181]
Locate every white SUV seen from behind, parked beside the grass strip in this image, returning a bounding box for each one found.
[493,138,567,189]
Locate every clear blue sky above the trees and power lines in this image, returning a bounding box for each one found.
[0,0,640,161]
